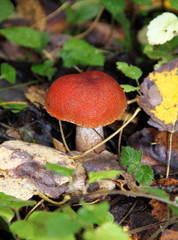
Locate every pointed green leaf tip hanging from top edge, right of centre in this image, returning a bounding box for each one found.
[101,0,126,16]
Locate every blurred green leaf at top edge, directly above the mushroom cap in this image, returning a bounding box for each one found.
[66,0,100,24]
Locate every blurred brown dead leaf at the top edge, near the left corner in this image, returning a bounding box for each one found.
[16,0,46,31]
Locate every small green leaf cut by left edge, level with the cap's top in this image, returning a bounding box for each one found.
[0,63,16,83]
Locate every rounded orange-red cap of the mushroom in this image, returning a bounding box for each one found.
[45,71,127,128]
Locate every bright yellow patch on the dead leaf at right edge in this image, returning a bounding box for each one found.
[149,68,178,124]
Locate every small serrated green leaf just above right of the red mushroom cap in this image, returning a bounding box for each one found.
[116,62,142,80]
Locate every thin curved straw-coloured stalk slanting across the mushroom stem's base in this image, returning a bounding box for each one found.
[71,108,141,160]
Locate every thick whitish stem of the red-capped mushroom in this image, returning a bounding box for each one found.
[76,126,105,153]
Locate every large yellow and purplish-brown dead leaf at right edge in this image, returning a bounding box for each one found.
[138,58,178,132]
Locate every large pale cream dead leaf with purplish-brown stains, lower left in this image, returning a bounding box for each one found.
[0,140,75,199]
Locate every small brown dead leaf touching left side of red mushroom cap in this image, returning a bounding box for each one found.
[25,85,46,106]
